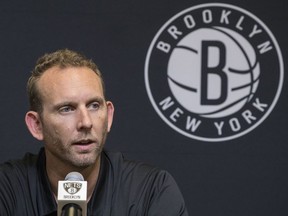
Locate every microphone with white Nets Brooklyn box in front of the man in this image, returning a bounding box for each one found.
[57,172,87,216]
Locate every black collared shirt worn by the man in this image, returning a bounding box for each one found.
[0,148,188,216]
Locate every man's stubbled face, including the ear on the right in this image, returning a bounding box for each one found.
[33,67,114,168]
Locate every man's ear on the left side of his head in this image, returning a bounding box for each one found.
[25,111,43,140]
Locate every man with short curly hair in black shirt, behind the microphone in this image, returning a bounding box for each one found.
[0,50,188,216]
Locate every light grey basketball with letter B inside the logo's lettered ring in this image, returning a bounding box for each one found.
[168,27,260,118]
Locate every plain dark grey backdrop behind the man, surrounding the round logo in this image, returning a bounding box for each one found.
[0,0,288,216]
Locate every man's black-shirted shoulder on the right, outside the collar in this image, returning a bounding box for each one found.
[102,152,188,216]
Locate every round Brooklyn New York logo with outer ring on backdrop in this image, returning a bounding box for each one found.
[145,3,284,142]
